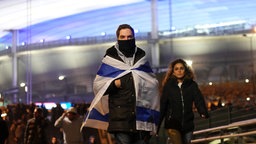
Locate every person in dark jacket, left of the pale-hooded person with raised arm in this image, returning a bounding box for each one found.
[24,107,49,144]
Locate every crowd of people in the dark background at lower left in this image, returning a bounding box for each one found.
[0,103,94,144]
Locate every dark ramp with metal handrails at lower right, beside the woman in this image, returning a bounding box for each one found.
[192,106,256,144]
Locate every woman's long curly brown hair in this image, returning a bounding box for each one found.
[161,59,195,92]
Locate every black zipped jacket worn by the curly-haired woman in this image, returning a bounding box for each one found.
[160,77,209,133]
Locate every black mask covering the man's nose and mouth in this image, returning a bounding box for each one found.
[118,39,136,57]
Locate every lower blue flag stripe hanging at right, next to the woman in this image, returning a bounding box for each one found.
[136,107,160,124]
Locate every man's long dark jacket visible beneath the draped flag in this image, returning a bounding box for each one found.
[106,47,145,132]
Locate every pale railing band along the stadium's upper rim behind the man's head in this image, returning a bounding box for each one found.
[0,24,251,51]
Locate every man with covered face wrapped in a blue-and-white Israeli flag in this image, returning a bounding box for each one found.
[83,24,160,144]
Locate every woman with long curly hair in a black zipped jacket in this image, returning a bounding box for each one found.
[158,59,209,144]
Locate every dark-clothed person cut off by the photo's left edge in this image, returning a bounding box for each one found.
[0,109,9,144]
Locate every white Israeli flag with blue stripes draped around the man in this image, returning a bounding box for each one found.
[82,56,160,132]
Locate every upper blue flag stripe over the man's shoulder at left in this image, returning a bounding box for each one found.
[97,63,125,78]
